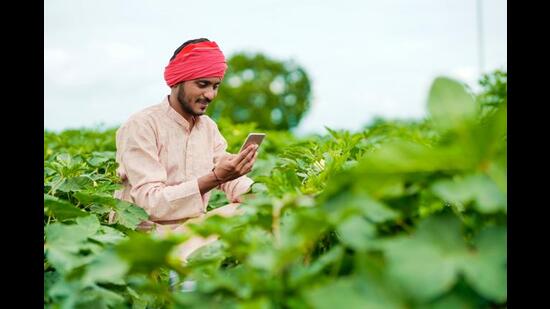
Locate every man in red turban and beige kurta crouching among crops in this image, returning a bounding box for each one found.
[115,39,257,259]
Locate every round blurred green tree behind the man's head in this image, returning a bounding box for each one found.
[208,53,311,130]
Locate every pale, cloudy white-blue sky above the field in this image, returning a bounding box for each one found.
[44,0,507,134]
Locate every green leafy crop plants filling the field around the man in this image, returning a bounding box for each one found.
[44,73,507,308]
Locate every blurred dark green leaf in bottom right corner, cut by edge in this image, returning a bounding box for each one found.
[462,227,507,303]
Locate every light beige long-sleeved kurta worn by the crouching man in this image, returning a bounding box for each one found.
[115,97,253,228]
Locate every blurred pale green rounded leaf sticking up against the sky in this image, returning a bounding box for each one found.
[428,77,476,130]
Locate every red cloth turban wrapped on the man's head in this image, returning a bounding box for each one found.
[164,42,227,87]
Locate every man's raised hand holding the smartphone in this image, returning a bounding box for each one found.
[214,144,258,182]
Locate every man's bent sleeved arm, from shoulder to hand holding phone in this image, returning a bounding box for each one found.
[117,120,253,220]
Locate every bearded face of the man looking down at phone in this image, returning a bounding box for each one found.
[178,77,221,116]
